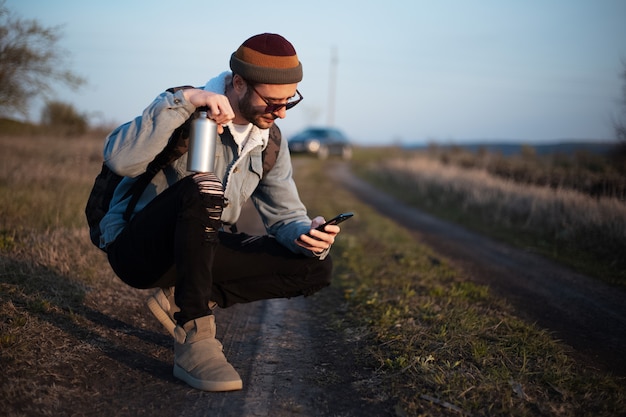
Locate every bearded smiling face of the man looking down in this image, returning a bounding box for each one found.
[238,84,297,129]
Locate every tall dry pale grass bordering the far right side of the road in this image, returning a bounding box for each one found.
[346,146,626,287]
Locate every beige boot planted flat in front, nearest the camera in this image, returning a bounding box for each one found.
[174,315,243,391]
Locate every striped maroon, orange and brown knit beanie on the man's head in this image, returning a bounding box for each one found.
[230,33,302,84]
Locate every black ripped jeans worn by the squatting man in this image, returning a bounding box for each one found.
[107,177,332,324]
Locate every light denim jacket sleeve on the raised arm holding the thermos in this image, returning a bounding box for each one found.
[104,90,195,177]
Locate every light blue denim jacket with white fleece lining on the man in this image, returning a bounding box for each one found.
[100,75,328,258]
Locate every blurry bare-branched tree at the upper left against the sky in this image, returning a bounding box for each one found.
[0,0,85,116]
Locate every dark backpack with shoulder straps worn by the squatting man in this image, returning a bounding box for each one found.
[85,86,282,248]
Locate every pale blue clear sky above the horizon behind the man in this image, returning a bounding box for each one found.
[5,0,626,145]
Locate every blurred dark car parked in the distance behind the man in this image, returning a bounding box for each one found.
[289,127,352,160]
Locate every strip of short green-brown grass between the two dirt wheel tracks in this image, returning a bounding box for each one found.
[296,154,626,416]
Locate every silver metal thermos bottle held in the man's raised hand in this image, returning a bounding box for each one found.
[187,111,217,172]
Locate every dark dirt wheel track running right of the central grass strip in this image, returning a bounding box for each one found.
[330,164,626,376]
